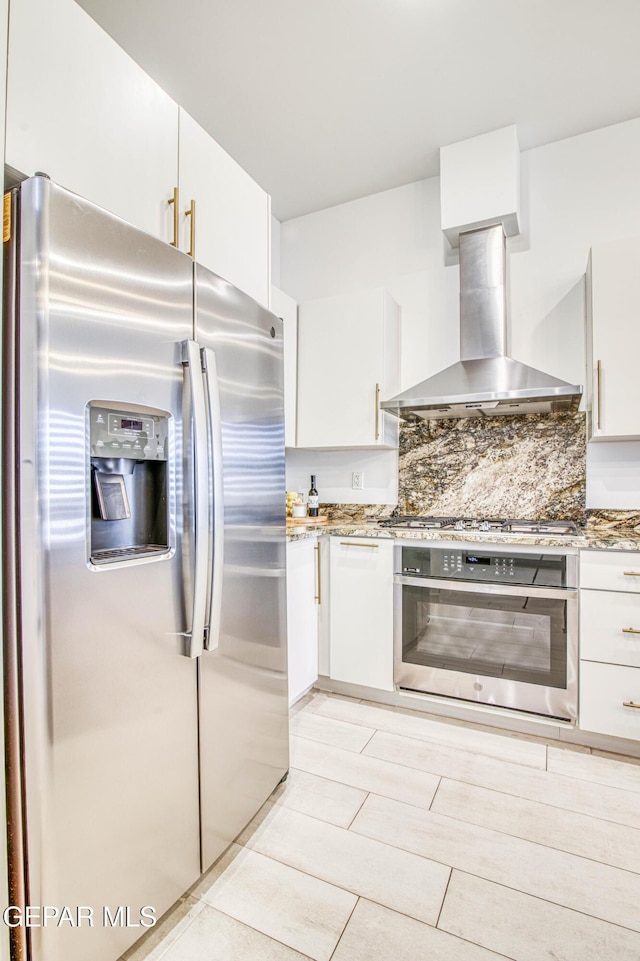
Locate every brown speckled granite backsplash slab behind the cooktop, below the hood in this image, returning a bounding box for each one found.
[399,412,586,523]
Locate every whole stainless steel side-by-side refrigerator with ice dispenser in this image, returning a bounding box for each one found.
[3,176,288,961]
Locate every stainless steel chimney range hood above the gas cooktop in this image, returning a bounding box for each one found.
[380,224,582,420]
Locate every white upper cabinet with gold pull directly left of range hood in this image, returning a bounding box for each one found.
[298,288,400,449]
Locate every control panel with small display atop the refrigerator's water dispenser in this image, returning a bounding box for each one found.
[89,405,169,460]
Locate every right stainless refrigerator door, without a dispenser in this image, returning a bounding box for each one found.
[195,265,289,870]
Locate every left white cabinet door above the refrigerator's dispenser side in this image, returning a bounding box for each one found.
[6,0,178,240]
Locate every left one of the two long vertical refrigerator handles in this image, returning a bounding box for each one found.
[182,340,209,657]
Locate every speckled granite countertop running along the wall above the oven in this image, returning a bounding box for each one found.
[287,521,640,551]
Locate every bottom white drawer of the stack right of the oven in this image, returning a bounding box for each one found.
[579,661,640,740]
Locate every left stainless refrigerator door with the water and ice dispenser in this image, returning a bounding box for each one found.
[6,177,201,961]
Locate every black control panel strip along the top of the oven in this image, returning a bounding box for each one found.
[400,547,567,587]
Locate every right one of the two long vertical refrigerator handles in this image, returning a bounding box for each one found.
[201,347,224,651]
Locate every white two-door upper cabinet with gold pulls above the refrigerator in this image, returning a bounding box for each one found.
[6,0,271,306]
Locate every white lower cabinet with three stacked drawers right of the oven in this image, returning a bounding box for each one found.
[579,551,640,740]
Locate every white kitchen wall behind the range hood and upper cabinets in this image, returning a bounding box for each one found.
[280,119,640,509]
